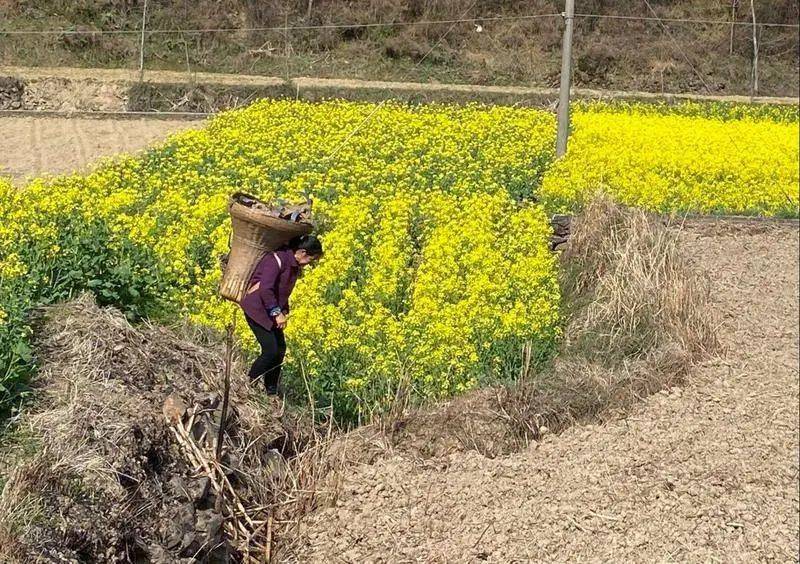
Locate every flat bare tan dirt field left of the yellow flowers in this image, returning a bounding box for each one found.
[0,116,201,183]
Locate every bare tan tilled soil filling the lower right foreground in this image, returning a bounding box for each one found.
[303,226,800,562]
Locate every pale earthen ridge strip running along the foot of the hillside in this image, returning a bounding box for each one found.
[0,66,798,113]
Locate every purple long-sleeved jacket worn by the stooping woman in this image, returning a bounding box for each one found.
[239,250,300,331]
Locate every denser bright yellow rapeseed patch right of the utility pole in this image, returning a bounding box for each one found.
[541,104,800,217]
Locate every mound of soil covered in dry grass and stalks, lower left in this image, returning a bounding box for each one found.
[0,297,310,563]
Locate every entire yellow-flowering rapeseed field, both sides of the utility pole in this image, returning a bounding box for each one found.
[0,101,798,420]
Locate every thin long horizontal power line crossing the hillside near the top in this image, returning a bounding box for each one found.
[0,13,800,35]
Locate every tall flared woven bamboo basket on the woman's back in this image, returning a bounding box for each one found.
[219,194,313,303]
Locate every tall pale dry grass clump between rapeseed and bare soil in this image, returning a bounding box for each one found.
[562,199,717,364]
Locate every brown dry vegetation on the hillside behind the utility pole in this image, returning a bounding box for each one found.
[0,0,799,96]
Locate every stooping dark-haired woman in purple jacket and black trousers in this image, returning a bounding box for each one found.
[240,235,322,395]
